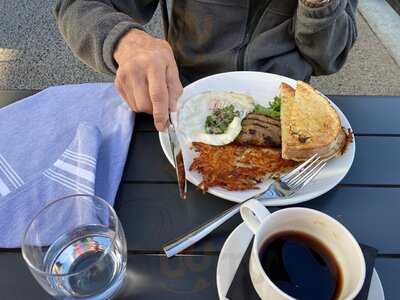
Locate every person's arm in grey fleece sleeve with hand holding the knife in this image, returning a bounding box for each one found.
[54,0,182,130]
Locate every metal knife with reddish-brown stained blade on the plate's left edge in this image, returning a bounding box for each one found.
[168,114,187,199]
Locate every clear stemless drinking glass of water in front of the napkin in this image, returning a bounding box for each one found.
[22,194,127,300]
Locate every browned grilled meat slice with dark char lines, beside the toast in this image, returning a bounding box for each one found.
[236,113,282,148]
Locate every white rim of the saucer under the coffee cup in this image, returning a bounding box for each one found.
[215,222,385,300]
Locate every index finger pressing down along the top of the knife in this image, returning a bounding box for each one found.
[147,67,169,131]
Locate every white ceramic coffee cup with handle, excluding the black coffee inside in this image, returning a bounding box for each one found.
[240,200,365,300]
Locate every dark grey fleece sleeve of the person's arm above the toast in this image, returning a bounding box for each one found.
[294,0,358,76]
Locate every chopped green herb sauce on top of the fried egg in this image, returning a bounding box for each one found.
[205,104,239,134]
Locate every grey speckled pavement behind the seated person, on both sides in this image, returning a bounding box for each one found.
[0,0,400,95]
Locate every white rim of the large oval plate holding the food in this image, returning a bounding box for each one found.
[159,71,356,206]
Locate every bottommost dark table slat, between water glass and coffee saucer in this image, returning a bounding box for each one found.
[0,253,218,300]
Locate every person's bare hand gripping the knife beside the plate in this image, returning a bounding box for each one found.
[114,29,182,131]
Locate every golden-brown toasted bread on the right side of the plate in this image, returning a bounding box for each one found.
[280,81,346,161]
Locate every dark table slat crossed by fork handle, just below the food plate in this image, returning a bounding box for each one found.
[115,184,400,254]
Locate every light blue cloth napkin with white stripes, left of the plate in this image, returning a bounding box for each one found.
[0,83,134,247]
